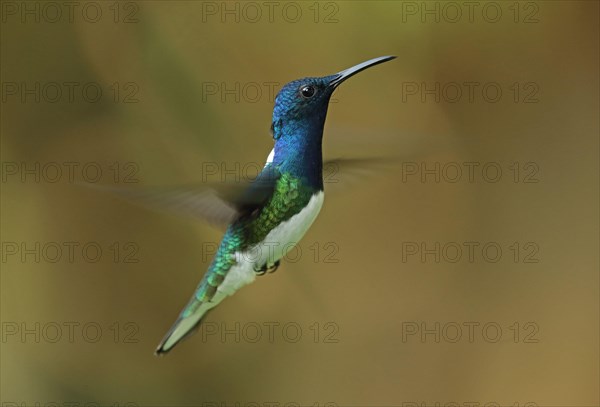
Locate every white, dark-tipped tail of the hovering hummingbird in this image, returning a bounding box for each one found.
[154,294,225,356]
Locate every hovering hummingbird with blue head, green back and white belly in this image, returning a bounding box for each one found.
[155,56,395,355]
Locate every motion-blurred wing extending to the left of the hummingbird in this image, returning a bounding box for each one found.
[83,165,279,230]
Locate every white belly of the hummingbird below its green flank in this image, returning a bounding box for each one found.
[215,191,325,299]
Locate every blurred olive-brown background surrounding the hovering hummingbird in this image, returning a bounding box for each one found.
[0,1,600,407]
